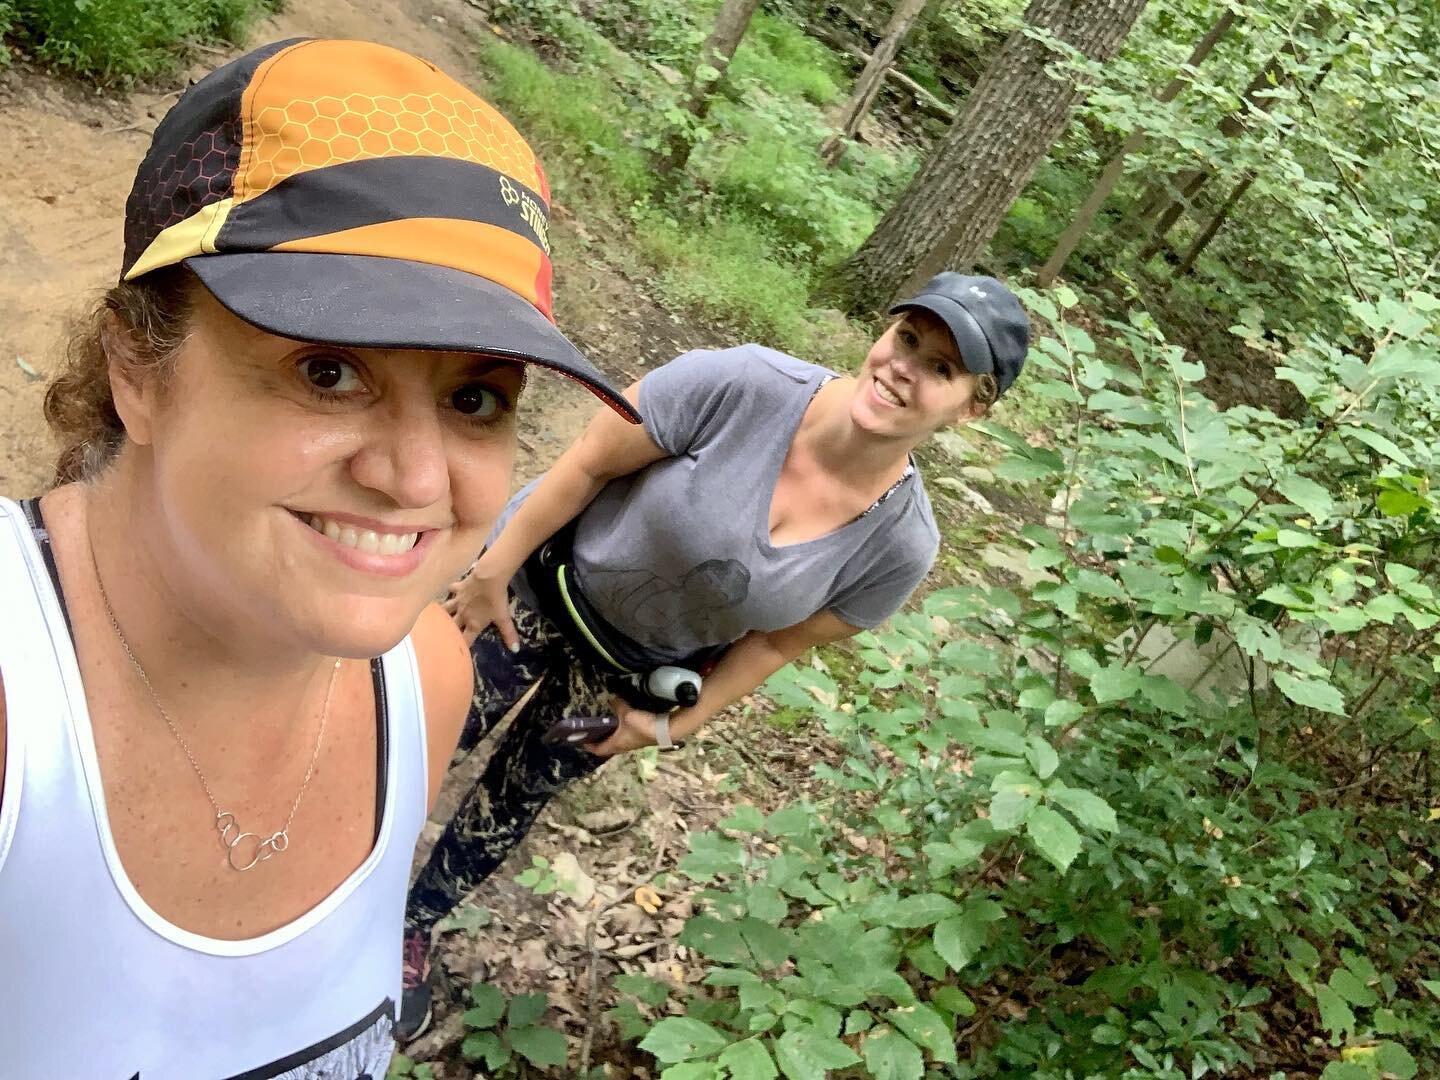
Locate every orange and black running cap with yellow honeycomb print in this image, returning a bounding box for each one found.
[121,39,639,422]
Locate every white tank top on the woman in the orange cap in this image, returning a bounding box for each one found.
[0,498,429,1080]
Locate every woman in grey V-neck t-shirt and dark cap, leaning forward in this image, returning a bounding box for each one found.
[405,266,1030,1027]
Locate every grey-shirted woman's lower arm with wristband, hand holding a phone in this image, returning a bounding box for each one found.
[586,611,860,757]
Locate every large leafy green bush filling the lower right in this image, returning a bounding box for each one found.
[618,280,1440,1080]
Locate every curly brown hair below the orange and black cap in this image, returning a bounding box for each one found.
[45,266,199,487]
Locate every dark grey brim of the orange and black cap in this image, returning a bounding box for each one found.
[184,252,641,423]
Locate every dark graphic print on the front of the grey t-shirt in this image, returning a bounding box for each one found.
[585,559,750,645]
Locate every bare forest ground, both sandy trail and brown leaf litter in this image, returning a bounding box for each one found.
[0,0,887,1077]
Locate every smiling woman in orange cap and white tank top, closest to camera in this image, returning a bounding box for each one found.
[0,40,634,1080]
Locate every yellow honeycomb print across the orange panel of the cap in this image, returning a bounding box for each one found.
[245,94,546,197]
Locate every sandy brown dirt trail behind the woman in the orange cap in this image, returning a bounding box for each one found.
[0,0,720,497]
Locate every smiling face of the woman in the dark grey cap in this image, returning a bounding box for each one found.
[850,311,978,439]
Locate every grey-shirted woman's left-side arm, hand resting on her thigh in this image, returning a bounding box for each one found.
[445,383,667,649]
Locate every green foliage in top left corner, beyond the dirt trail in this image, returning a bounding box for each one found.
[0,0,279,84]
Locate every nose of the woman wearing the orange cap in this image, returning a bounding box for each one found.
[350,395,449,510]
